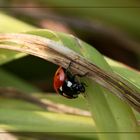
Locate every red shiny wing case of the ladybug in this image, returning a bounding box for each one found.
[53,67,66,93]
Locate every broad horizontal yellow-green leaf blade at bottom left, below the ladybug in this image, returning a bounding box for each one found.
[0,109,97,139]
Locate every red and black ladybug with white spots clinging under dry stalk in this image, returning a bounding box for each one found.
[53,66,85,99]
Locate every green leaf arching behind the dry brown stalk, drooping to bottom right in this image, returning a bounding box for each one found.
[0,30,139,140]
